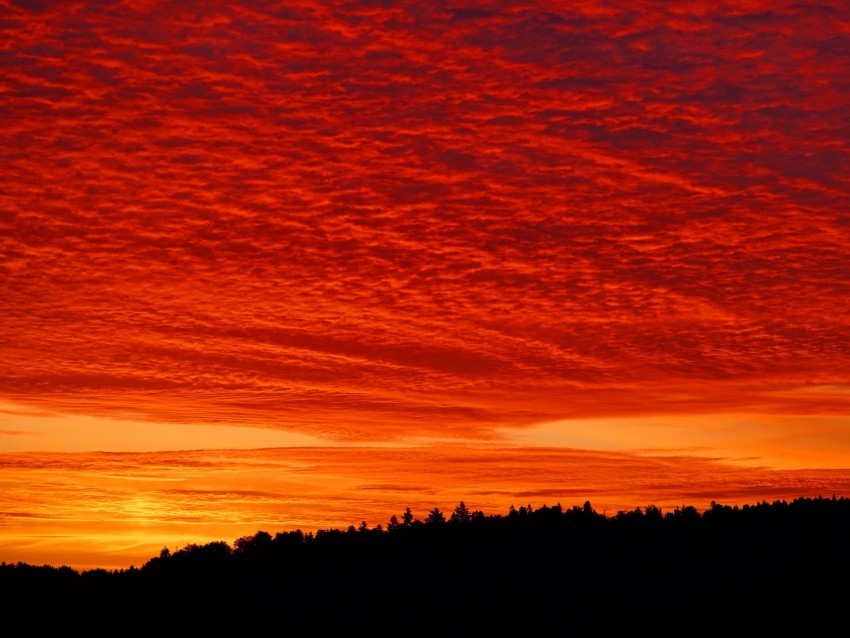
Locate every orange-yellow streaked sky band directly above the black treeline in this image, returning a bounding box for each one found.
[6,445,850,569]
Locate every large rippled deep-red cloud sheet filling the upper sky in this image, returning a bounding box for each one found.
[0,2,850,441]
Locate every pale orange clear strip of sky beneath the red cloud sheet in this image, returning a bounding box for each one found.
[0,402,850,470]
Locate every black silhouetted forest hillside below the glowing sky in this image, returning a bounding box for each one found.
[6,496,850,636]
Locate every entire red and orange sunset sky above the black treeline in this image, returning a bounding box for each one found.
[0,0,850,568]
